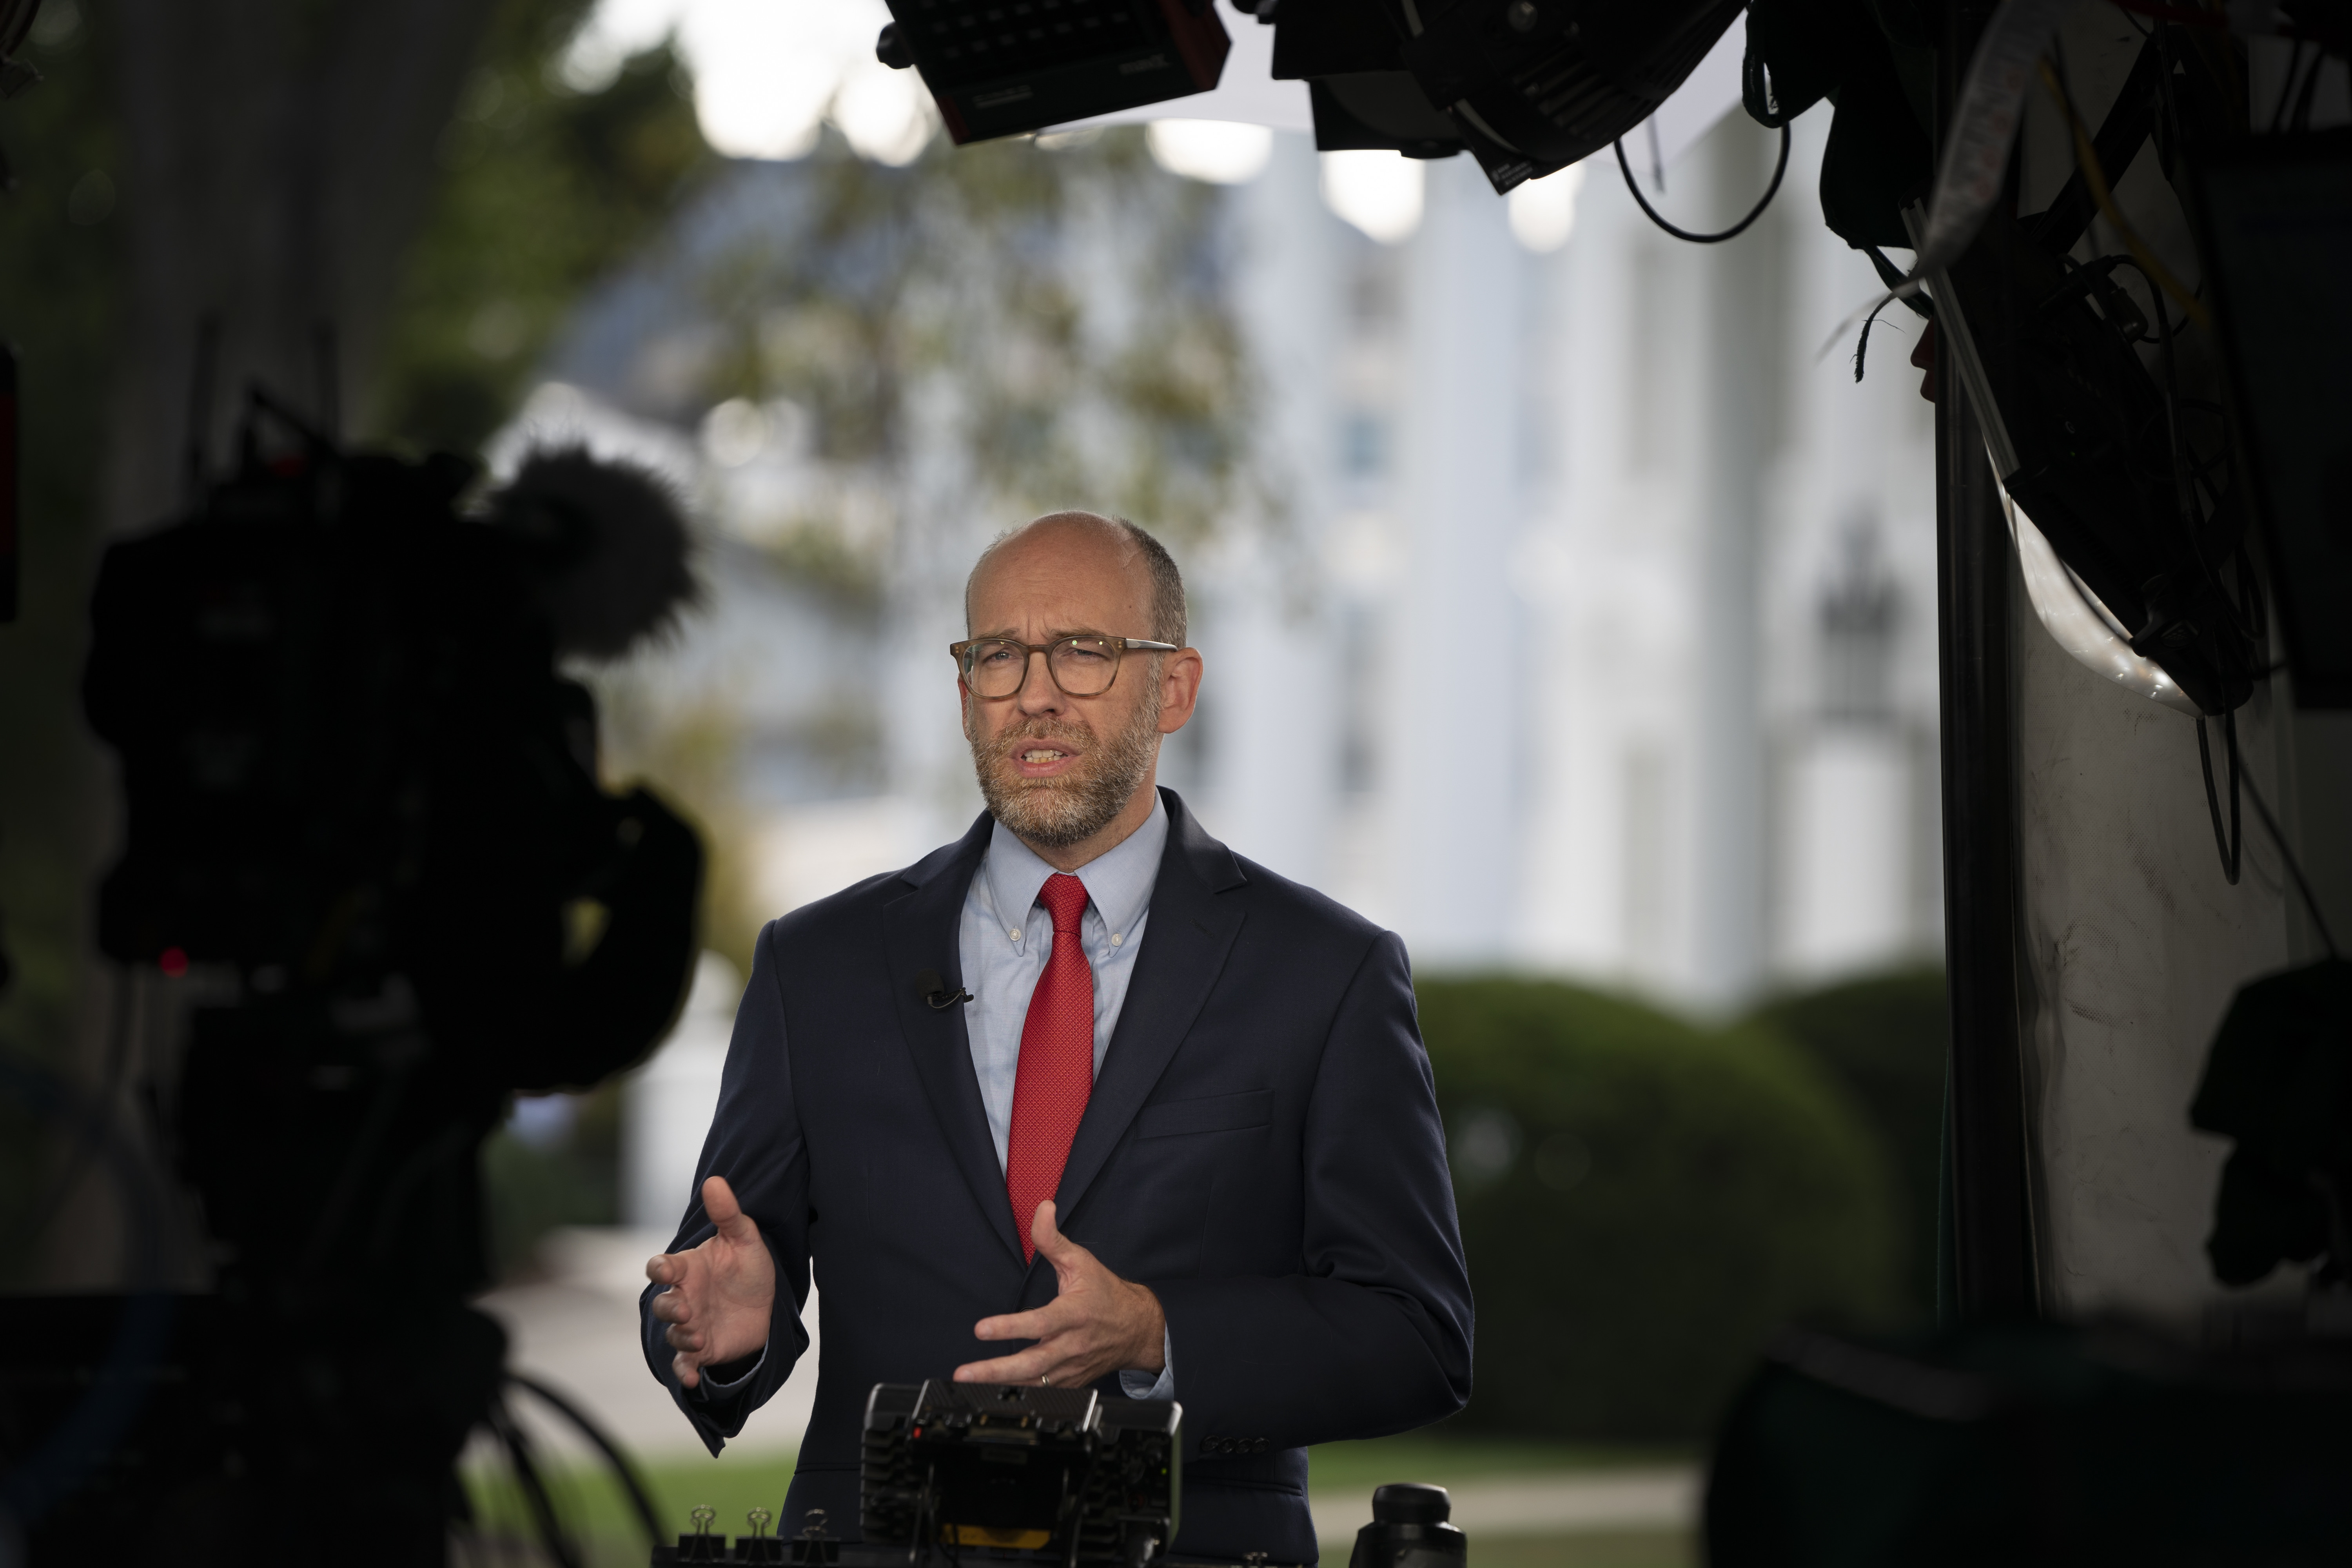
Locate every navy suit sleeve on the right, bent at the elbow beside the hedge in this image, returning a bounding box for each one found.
[1150,933,1470,1448]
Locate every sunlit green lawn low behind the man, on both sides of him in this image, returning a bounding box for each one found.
[468,1432,1696,1568]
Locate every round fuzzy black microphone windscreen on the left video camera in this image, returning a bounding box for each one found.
[489,446,701,658]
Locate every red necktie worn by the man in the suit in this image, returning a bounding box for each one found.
[1004,872,1094,1258]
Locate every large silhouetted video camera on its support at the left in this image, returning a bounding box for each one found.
[0,390,703,1568]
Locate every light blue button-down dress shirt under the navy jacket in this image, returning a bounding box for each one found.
[957,792,1176,1399]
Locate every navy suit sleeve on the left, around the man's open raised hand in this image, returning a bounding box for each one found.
[637,924,809,1453]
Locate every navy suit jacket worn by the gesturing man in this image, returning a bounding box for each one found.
[644,790,1470,1563]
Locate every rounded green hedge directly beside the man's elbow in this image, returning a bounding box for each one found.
[1418,978,1896,1439]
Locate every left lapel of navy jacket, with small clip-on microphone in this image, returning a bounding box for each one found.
[882,813,1021,1260]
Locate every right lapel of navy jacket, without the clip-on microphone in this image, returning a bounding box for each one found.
[1054,790,1244,1225]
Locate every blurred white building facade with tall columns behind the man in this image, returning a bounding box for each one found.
[1190,115,1940,1011]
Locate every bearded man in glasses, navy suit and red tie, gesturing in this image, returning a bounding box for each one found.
[644,512,1470,1563]
